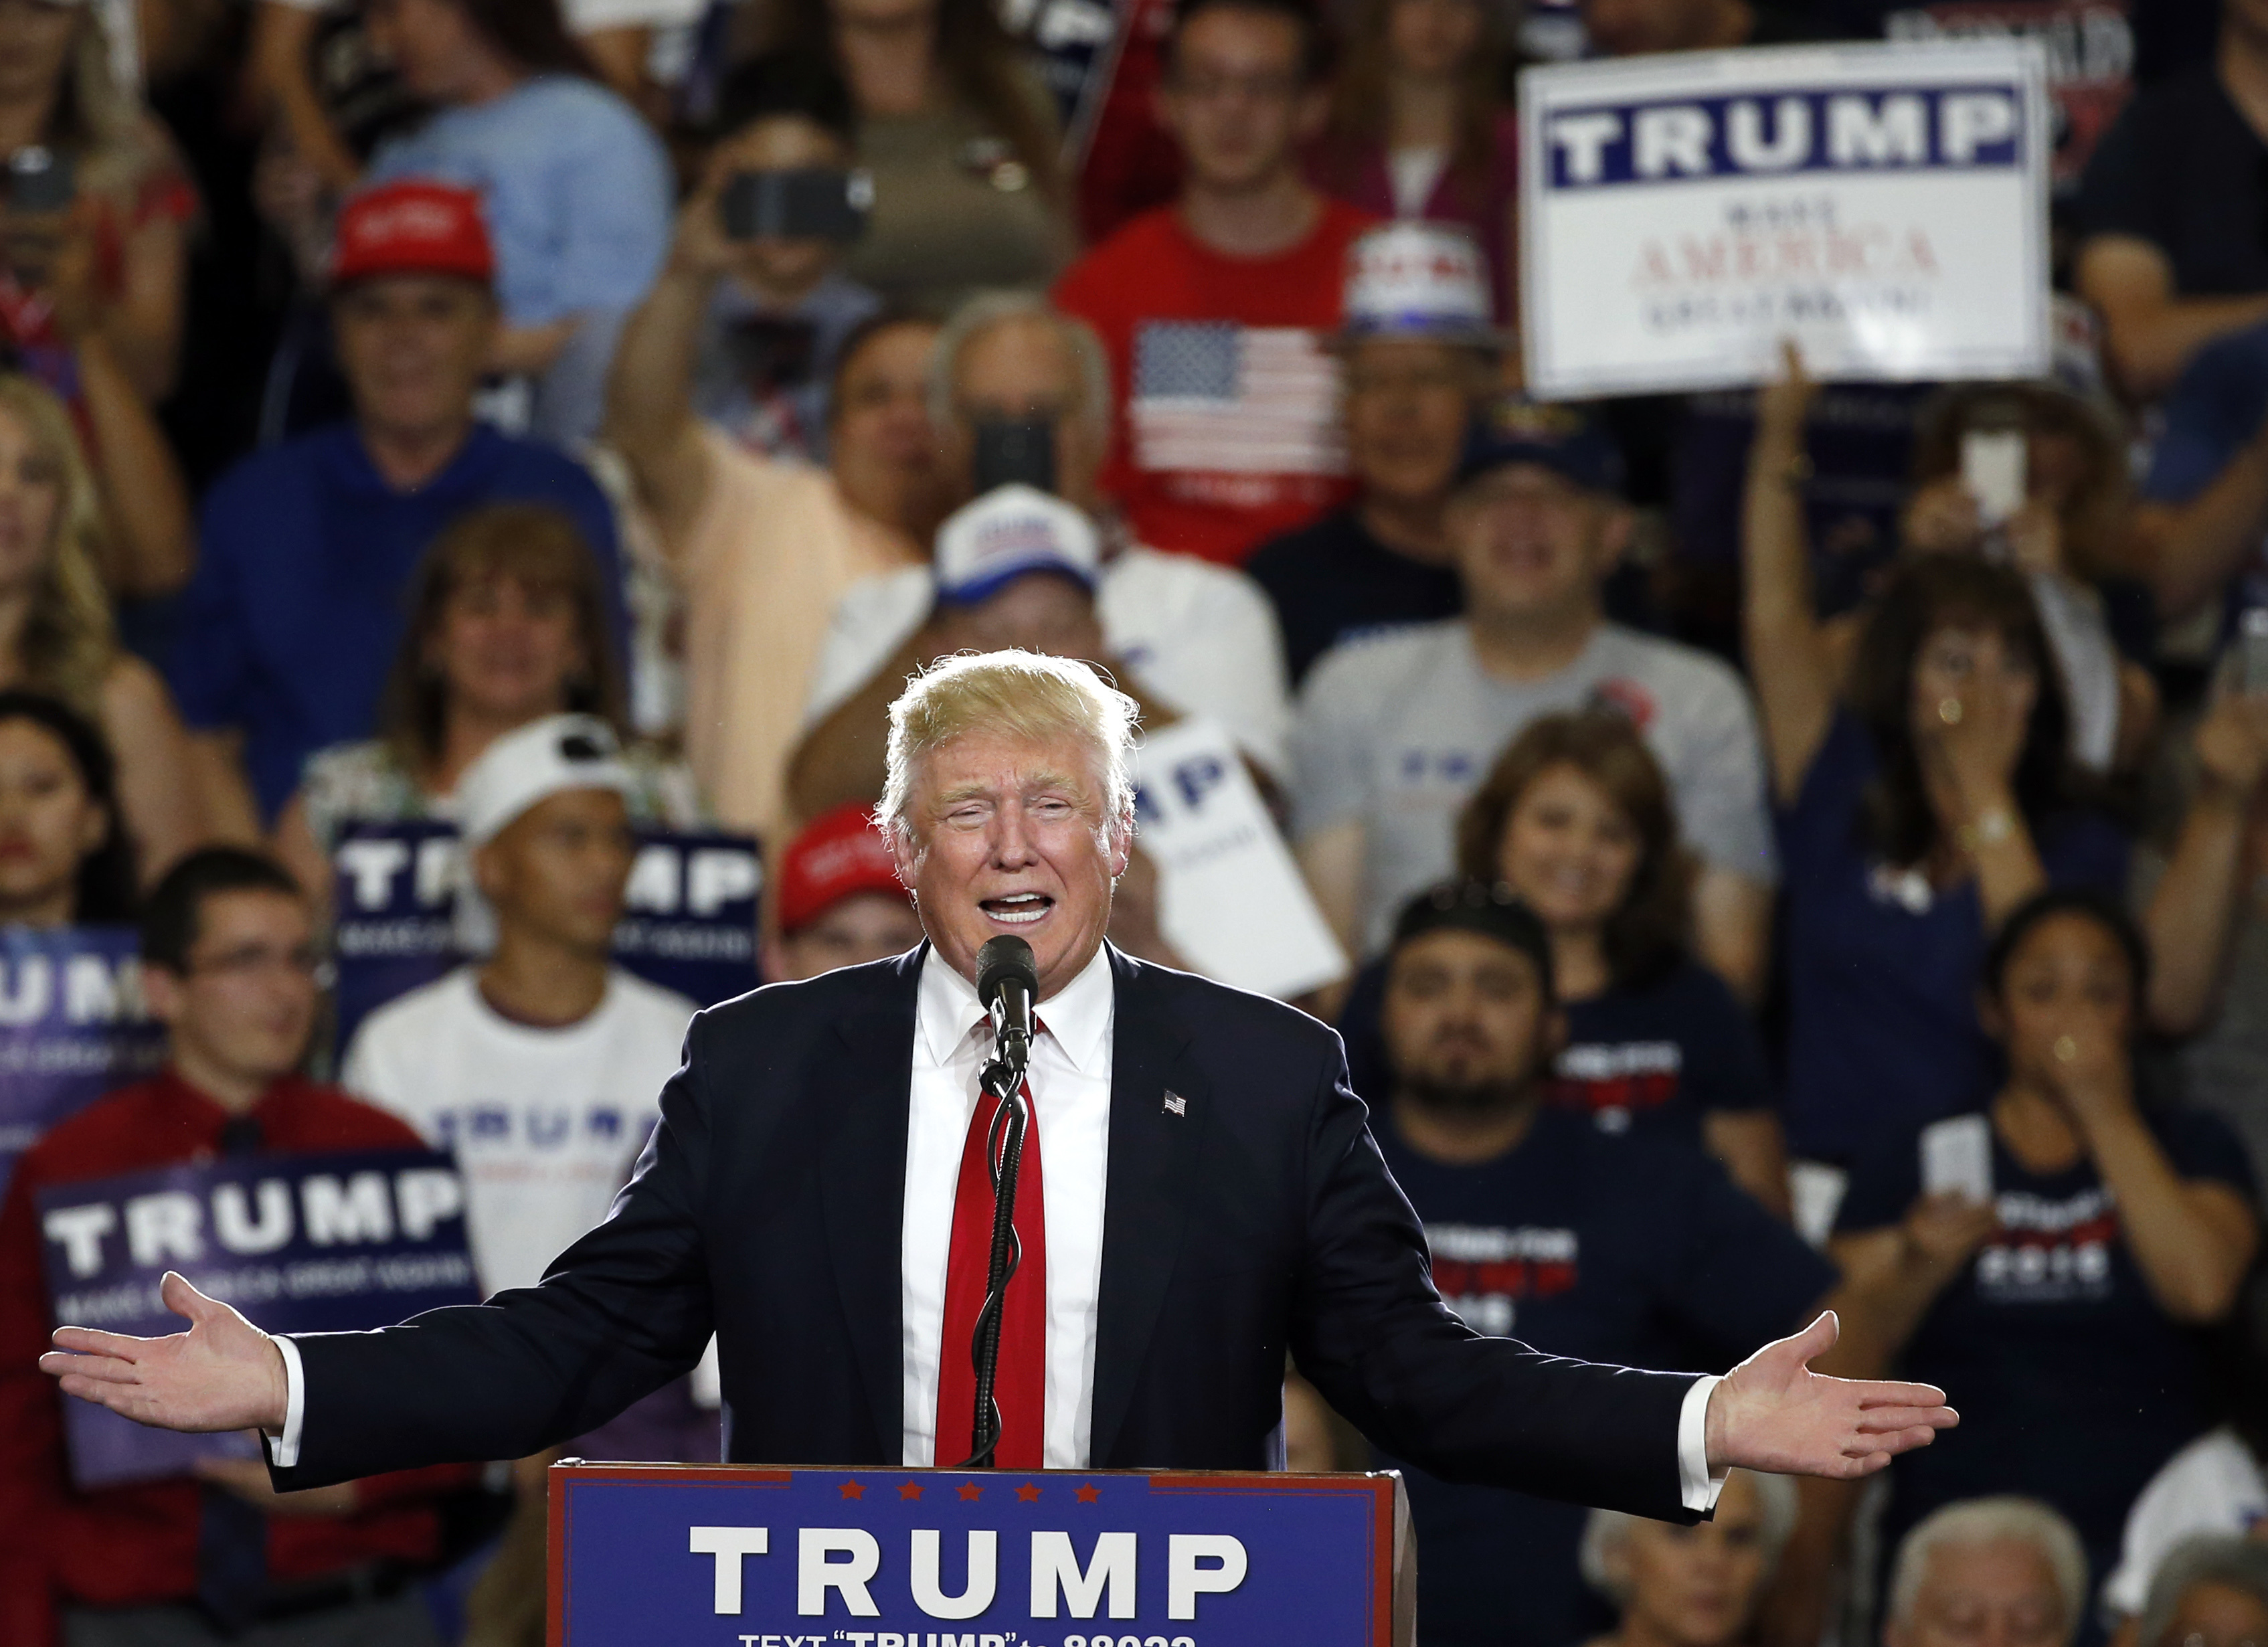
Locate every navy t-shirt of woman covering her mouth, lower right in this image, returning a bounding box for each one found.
[1837,1107,2252,1579]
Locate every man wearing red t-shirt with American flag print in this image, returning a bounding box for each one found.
[1055,0,1372,563]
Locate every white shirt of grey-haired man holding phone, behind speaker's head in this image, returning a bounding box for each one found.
[803,545,1290,778]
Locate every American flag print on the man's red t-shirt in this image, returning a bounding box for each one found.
[1130,320,1347,476]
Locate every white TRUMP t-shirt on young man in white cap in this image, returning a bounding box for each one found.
[343,966,694,1293]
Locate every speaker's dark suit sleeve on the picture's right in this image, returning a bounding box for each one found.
[1293,1053,1694,1523]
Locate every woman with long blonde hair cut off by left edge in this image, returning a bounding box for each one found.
[0,374,204,880]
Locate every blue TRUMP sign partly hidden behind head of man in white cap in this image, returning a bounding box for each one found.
[331,821,764,1048]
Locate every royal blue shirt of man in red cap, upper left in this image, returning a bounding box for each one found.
[168,424,628,819]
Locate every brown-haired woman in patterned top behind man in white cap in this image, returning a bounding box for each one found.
[274,504,703,907]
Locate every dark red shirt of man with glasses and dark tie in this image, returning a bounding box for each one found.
[0,1071,472,1647]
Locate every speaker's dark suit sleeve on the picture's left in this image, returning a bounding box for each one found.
[270,1019,712,1492]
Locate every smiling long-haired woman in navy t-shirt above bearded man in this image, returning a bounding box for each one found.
[1456,710,1787,1216]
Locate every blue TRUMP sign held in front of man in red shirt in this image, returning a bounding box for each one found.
[36,1150,481,1488]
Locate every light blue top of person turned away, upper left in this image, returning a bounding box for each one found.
[369,75,676,327]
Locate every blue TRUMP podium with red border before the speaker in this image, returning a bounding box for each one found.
[549,1459,1417,1647]
